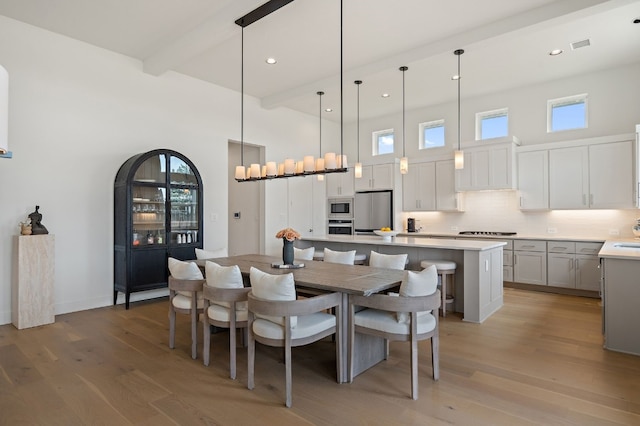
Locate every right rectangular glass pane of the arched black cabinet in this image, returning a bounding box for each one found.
[170,188,201,244]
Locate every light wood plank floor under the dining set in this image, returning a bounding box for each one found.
[0,289,640,425]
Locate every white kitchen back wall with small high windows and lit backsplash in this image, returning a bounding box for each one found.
[346,63,640,239]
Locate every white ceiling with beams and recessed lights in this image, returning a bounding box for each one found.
[0,0,640,122]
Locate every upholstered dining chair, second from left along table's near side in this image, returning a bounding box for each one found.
[202,261,251,379]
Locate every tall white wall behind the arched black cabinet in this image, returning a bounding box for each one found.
[0,16,338,324]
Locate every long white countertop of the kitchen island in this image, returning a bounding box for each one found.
[302,235,507,251]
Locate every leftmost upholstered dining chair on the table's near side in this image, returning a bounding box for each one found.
[168,257,205,359]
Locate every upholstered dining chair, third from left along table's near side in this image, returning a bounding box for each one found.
[247,268,343,407]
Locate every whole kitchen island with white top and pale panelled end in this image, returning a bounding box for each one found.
[296,235,506,323]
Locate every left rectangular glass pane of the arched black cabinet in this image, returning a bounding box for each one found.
[131,184,166,247]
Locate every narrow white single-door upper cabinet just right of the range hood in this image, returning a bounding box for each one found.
[517,150,549,210]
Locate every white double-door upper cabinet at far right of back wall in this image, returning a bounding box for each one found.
[549,141,635,209]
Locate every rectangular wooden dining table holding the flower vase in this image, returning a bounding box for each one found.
[194,254,405,383]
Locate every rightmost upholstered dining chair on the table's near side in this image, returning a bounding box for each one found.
[347,267,440,400]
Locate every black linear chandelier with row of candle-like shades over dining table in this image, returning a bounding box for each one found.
[235,0,348,182]
